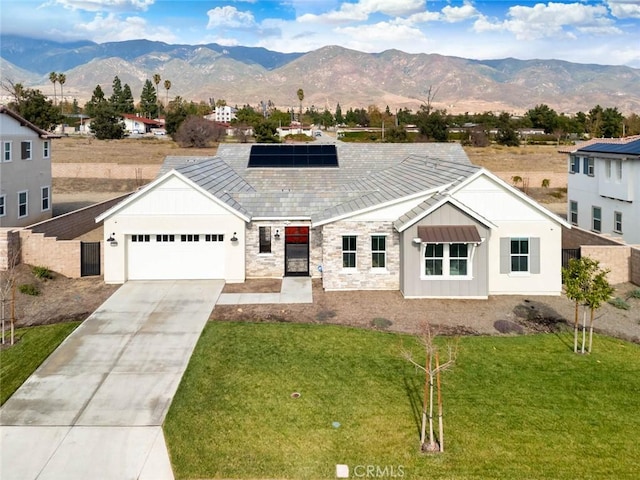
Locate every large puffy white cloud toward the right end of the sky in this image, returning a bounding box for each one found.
[474,2,620,40]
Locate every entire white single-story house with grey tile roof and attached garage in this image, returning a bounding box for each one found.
[97,142,569,298]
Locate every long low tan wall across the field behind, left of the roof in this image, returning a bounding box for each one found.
[51,163,160,180]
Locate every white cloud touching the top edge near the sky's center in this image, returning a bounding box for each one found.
[297,0,425,25]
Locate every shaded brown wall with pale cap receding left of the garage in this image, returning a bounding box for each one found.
[27,193,131,240]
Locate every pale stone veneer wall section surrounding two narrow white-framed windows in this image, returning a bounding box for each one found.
[322,221,400,290]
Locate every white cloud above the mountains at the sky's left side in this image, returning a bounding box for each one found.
[75,13,176,43]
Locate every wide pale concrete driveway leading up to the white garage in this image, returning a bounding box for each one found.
[0,280,224,480]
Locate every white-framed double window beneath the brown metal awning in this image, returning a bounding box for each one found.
[424,243,472,277]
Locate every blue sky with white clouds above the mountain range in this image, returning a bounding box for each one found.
[0,0,640,68]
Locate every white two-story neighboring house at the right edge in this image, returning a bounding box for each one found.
[567,136,640,244]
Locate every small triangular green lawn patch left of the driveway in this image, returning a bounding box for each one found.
[0,322,80,405]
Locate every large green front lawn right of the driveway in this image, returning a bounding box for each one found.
[165,322,640,479]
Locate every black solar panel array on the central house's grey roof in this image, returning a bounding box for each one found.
[248,144,338,168]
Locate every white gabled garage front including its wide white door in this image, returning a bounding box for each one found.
[104,176,245,283]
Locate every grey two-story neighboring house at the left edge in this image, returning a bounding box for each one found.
[0,105,56,227]
